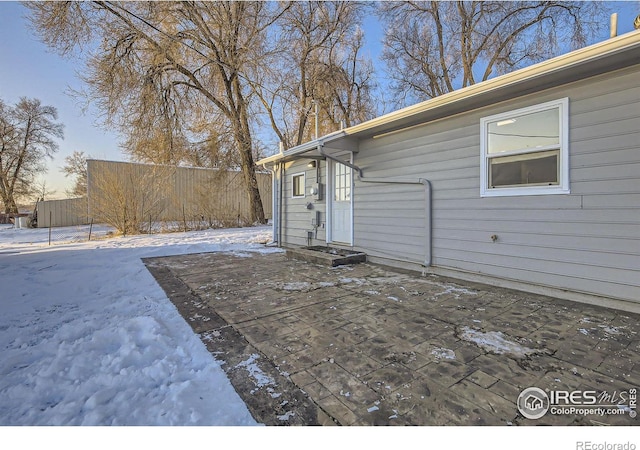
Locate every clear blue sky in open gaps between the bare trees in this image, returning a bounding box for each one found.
[0,1,640,198]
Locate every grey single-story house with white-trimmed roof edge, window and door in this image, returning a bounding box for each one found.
[259,31,640,311]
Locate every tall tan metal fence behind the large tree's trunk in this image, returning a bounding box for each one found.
[87,160,272,225]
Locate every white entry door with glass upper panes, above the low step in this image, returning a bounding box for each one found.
[331,162,353,245]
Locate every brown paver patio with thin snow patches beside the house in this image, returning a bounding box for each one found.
[145,252,640,425]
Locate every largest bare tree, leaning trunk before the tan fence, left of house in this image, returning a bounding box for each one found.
[27,1,281,223]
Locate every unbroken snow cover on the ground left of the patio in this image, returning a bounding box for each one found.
[0,226,278,425]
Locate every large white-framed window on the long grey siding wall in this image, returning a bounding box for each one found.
[480,98,569,197]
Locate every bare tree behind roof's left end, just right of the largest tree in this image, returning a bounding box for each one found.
[252,1,375,148]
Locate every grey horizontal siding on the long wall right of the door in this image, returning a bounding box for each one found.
[354,66,640,302]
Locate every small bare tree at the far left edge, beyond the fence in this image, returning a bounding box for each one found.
[0,97,64,213]
